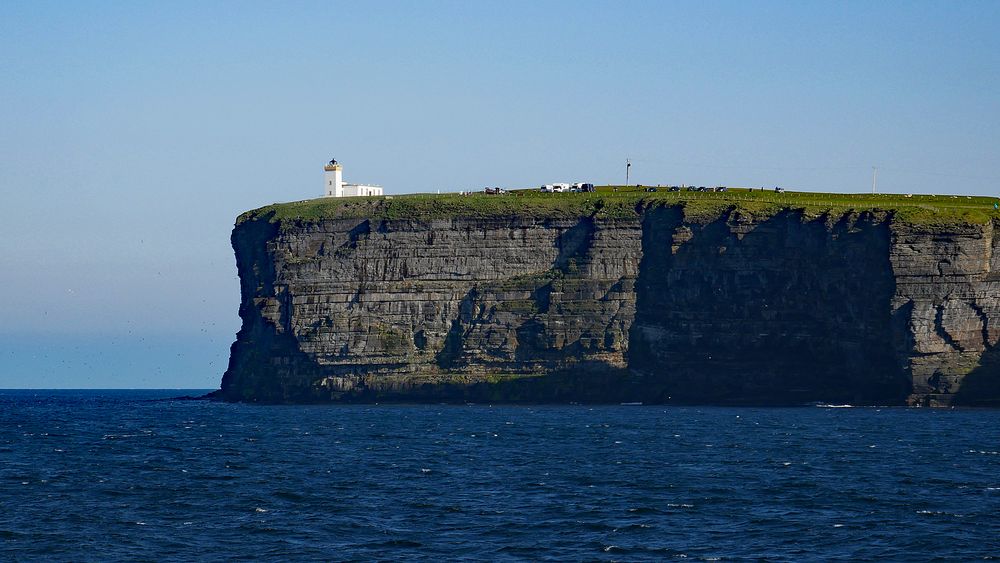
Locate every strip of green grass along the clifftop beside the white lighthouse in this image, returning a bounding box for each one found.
[237,186,1000,225]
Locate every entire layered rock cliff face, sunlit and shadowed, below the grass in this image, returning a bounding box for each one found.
[219,208,1000,405]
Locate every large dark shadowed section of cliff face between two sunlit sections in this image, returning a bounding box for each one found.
[630,209,907,404]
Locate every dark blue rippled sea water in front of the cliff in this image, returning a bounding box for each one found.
[0,391,1000,561]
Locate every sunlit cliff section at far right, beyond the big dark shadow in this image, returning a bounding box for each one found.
[889,223,1000,406]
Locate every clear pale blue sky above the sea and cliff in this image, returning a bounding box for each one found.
[0,0,1000,388]
